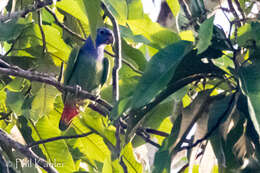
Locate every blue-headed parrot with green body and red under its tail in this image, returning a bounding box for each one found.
[59,28,114,130]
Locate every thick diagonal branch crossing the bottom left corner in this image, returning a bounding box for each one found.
[0,129,58,173]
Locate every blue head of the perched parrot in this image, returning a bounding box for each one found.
[96,28,114,47]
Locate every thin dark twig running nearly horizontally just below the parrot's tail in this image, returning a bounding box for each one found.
[27,131,93,148]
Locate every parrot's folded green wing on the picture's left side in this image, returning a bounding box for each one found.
[63,47,80,85]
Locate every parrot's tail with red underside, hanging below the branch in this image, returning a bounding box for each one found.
[59,104,79,131]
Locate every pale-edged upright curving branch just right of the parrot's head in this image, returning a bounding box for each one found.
[101,2,122,103]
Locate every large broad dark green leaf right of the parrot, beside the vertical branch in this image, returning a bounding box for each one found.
[132,41,192,108]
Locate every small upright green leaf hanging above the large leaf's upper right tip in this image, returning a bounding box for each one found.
[197,16,215,54]
